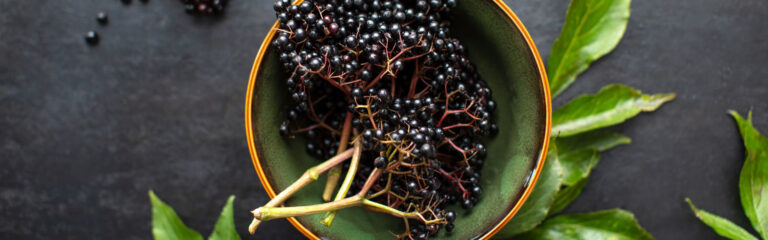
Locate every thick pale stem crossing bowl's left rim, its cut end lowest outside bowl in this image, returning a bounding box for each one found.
[248,149,353,234]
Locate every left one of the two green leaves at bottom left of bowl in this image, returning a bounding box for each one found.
[149,191,203,240]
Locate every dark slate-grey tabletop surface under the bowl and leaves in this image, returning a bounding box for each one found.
[0,0,768,239]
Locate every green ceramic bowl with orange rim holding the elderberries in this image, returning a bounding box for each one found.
[245,0,552,239]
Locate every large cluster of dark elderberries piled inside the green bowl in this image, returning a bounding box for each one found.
[271,0,498,239]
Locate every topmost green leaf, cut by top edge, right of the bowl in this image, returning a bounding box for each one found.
[547,0,631,97]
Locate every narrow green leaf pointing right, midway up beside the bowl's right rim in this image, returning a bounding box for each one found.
[552,84,675,137]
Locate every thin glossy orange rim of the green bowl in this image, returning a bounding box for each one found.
[245,0,552,240]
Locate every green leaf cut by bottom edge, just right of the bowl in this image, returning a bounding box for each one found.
[519,209,653,240]
